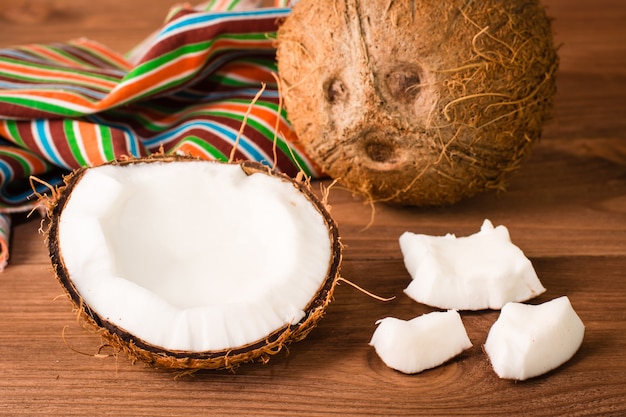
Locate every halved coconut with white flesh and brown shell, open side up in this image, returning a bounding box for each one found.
[48,156,341,369]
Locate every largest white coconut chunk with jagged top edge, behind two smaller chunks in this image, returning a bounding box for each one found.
[400,220,546,310]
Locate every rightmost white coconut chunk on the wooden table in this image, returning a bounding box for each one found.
[485,296,585,380]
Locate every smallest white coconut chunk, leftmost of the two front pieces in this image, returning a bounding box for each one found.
[370,310,472,374]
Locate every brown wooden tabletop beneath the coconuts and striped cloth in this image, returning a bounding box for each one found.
[0,0,626,416]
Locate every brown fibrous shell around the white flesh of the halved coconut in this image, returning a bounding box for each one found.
[47,155,342,371]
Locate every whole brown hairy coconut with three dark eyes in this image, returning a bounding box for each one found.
[276,0,558,206]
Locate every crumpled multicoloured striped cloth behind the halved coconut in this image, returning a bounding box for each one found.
[0,0,312,269]
